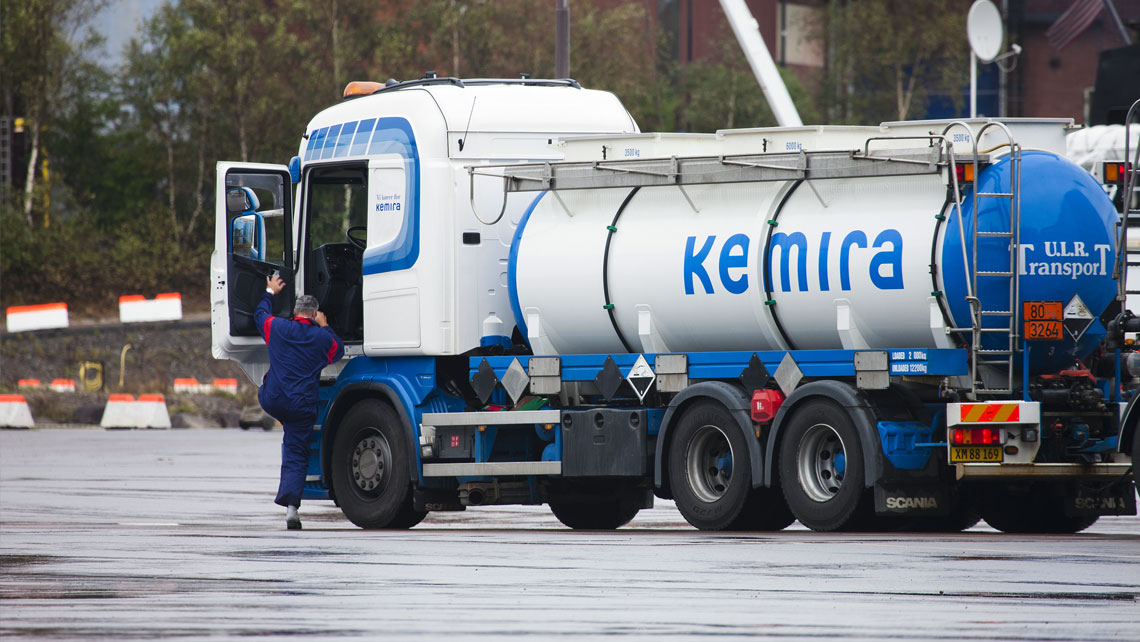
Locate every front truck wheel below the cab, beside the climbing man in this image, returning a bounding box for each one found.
[329,399,426,528]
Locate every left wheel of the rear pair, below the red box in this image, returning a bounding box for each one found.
[668,401,752,530]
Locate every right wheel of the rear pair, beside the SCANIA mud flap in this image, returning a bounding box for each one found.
[780,400,870,530]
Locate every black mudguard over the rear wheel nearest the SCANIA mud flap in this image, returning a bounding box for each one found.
[764,380,882,488]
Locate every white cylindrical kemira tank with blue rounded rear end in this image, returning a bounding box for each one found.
[508,153,1117,372]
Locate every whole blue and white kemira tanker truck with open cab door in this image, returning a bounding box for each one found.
[211,76,1140,533]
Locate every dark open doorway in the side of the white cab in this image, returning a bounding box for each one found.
[304,165,368,341]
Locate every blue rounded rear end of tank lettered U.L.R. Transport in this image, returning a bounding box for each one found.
[941,152,1118,374]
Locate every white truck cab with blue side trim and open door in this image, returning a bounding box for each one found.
[211,78,638,383]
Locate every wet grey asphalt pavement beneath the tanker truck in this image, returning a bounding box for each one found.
[0,429,1140,642]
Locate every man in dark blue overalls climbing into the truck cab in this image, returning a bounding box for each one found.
[253,274,344,530]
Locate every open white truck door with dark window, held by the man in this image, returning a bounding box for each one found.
[210,162,296,385]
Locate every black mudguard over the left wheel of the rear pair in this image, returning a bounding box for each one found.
[653,381,765,497]
